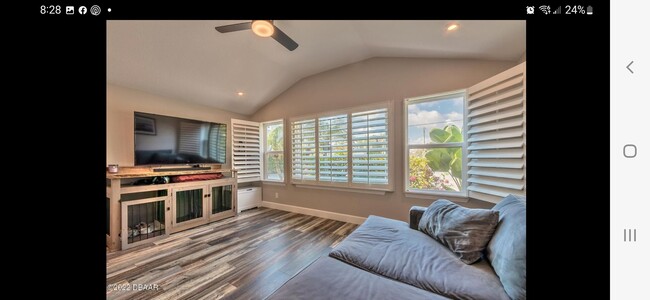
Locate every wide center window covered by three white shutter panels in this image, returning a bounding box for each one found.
[291,104,392,190]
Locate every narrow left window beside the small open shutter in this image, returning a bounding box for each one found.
[262,120,284,182]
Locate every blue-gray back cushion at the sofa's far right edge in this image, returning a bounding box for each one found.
[485,195,526,299]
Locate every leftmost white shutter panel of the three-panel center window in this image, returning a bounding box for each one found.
[291,119,316,182]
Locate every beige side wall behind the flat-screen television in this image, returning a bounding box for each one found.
[106,84,248,166]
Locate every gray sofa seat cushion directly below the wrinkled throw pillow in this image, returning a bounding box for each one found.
[330,216,509,300]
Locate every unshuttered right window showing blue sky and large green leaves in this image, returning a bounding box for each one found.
[405,91,466,196]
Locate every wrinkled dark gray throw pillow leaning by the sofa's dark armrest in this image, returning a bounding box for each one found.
[418,199,499,264]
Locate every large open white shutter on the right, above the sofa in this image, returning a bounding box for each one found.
[467,62,526,203]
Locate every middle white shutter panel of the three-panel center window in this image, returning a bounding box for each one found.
[318,114,348,183]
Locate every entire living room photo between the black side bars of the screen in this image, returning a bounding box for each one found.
[105,20,520,299]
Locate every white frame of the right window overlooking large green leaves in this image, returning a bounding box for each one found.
[402,89,468,198]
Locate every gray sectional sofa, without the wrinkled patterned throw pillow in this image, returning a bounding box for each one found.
[268,195,526,300]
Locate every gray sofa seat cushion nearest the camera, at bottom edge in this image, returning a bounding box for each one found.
[266,256,447,300]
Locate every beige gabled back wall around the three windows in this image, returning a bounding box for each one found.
[252,58,517,220]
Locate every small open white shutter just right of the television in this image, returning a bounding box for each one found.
[231,119,262,182]
